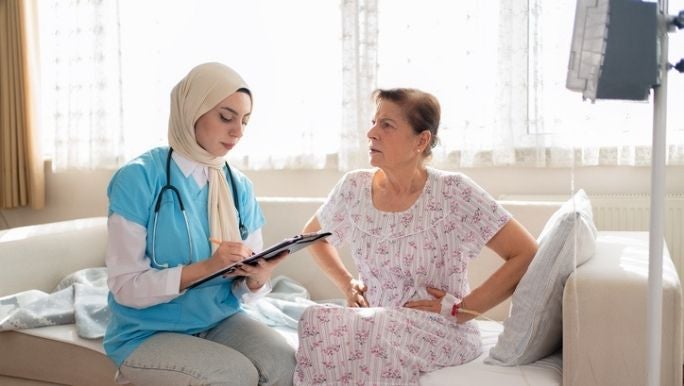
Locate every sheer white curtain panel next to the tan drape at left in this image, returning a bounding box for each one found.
[38,0,123,170]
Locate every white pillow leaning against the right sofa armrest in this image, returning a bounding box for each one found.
[485,189,597,366]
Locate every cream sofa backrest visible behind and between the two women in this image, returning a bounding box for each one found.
[0,197,560,320]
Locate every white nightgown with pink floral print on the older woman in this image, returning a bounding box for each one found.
[294,168,510,385]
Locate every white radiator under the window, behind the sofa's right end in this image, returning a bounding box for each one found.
[499,194,684,280]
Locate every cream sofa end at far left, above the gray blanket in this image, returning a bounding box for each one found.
[0,217,107,297]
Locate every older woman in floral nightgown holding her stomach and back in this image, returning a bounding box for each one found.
[295,89,537,385]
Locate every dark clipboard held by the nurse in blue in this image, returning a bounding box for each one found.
[186,232,332,289]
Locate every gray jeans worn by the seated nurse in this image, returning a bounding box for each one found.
[119,312,295,386]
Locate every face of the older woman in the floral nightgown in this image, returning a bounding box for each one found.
[367,100,429,168]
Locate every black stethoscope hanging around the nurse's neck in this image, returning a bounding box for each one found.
[152,148,248,268]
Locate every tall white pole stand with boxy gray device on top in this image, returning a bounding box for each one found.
[566,0,684,386]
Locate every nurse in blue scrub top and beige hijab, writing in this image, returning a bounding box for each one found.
[104,63,295,386]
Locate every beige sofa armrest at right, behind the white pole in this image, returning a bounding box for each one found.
[563,232,682,386]
